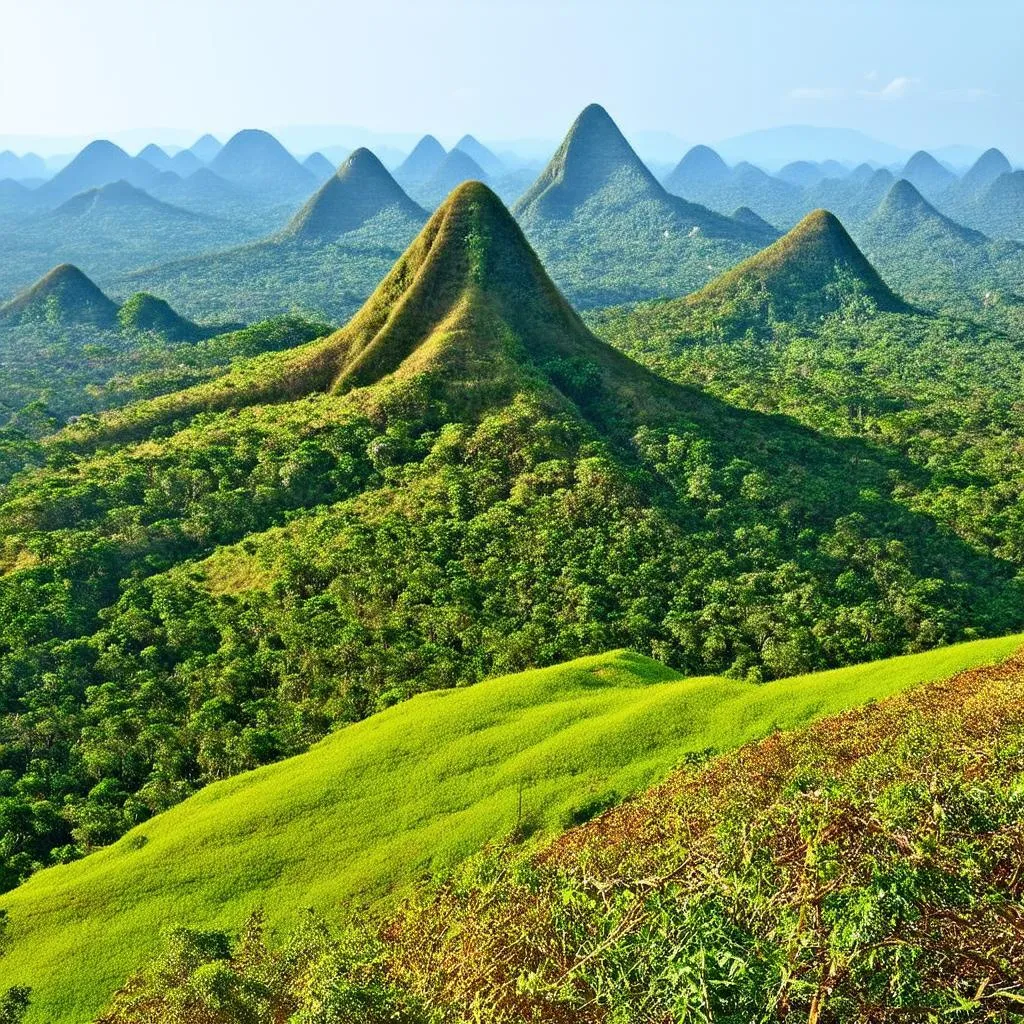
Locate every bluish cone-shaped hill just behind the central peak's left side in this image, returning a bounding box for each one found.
[284,148,426,242]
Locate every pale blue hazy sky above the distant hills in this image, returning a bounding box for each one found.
[0,0,1024,159]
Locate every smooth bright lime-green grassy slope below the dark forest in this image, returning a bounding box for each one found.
[0,636,1024,1024]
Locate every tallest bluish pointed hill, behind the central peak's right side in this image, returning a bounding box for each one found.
[514,104,774,306]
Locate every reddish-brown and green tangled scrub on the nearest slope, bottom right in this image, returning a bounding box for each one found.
[97,657,1024,1024]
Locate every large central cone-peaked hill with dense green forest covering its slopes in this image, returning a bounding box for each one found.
[0,184,1022,913]
